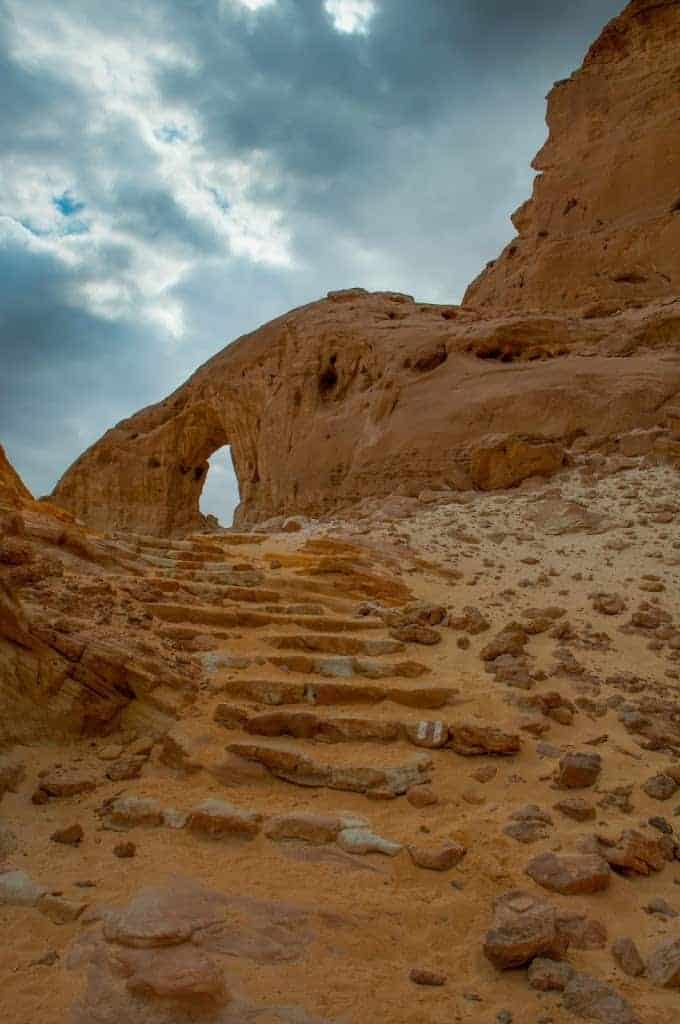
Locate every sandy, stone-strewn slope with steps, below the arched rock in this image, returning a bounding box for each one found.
[0,460,680,1024]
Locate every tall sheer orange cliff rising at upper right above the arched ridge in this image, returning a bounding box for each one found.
[465,0,680,311]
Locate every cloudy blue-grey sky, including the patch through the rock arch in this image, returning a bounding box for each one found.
[0,0,624,521]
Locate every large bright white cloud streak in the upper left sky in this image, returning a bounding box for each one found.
[0,0,292,339]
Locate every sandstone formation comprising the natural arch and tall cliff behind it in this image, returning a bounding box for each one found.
[47,0,680,535]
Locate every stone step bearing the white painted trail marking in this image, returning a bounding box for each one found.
[213,703,520,757]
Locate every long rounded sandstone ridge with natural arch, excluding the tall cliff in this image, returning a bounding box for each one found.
[53,290,680,535]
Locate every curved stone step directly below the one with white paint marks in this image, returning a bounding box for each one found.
[226,739,431,799]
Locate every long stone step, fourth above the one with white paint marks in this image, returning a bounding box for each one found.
[147,602,378,630]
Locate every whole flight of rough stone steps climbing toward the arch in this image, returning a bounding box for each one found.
[103,534,519,823]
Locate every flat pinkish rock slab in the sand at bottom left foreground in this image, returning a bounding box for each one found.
[68,878,337,1024]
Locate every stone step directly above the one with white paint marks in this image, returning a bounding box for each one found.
[212,679,450,710]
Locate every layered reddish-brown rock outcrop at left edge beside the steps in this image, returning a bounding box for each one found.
[0,479,196,749]
